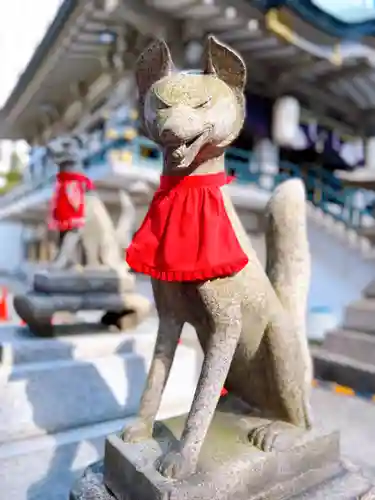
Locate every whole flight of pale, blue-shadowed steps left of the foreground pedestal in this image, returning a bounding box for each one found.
[0,317,201,500]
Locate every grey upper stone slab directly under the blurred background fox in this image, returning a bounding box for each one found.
[34,265,135,295]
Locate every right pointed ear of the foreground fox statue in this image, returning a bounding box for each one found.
[203,36,246,91]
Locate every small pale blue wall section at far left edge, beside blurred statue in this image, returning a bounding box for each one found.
[0,221,23,272]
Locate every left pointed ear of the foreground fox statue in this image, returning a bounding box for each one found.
[135,40,173,102]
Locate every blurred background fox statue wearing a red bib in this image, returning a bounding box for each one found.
[47,135,136,268]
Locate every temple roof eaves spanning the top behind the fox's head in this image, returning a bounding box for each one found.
[5,0,375,139]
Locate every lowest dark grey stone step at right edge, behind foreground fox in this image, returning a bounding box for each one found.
[311,347,375,394]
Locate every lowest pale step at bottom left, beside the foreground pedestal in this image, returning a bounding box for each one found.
[0,400,186,500]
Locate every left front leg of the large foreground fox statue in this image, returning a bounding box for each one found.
[122,316,183,443]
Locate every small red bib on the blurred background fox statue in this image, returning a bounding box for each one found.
[49,172,94,231]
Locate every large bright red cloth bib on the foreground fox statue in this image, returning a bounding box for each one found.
[126,172,248,281]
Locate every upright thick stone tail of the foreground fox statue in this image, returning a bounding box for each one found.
[266,179,313,391]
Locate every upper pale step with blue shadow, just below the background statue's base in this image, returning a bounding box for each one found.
[0,319,201,443]
